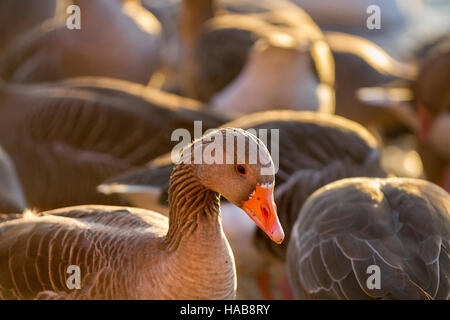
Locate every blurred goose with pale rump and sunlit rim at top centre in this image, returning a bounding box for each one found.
[180,0,334,113]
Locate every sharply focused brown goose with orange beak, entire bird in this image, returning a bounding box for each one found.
[0,128,284,299]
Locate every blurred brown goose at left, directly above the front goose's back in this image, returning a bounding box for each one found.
[0,78,227,210]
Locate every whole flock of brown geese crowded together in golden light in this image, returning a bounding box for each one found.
[0,0,450,299]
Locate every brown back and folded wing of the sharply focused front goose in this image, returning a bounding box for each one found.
[0,206,167,299]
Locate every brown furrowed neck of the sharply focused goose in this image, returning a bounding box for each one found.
[165,163,220,251]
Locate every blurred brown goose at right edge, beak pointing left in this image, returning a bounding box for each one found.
[358,36,450,190]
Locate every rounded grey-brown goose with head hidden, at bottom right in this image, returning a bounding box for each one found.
[287,177,450,300]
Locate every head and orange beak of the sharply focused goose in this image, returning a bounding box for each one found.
[178,128,284,243]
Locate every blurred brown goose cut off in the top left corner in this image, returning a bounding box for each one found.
[0,0,56,54]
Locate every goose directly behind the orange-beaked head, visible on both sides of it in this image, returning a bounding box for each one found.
[98,110,386,299]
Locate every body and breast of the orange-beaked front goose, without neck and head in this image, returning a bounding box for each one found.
[0,206,235,299]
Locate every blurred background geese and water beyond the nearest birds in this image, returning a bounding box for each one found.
[0,0,450,299]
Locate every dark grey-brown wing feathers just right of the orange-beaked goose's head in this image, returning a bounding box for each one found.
[251,117,386,258]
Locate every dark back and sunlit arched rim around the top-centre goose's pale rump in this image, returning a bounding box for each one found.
[180,1,334,110]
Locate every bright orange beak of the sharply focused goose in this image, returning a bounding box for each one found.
[241,186,284,244]
